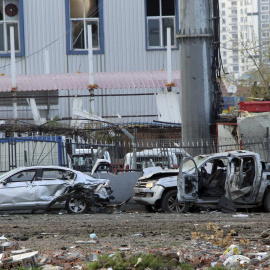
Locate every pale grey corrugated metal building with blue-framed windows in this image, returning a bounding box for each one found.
[0,0,179,125]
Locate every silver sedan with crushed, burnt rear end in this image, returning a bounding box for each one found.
[0,166,111,214]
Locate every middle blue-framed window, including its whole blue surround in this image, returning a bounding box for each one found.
[66,0,104,54]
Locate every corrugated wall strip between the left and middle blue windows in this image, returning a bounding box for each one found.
[23,0,67,74]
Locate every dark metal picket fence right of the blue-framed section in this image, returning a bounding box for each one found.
[62,138,270,171]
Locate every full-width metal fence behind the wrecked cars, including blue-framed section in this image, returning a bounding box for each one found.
[0,136,270,173]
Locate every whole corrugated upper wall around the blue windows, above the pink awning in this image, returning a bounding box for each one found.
[0,0,179,74]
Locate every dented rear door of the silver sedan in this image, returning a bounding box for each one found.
[33,168,76,207]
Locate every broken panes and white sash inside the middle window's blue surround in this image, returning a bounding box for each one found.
[69,0,100,50]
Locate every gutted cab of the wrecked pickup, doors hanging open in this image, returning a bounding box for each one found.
[177,150,270,212]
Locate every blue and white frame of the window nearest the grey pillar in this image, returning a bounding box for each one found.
[144,0,179,51]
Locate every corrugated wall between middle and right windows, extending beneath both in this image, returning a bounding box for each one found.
[68,0,179,73]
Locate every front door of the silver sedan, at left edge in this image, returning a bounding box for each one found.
[0,169,37,210]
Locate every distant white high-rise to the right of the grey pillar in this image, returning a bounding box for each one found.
[220,0,270,78]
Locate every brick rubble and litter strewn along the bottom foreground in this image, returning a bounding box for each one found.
[0,238,270,270]
